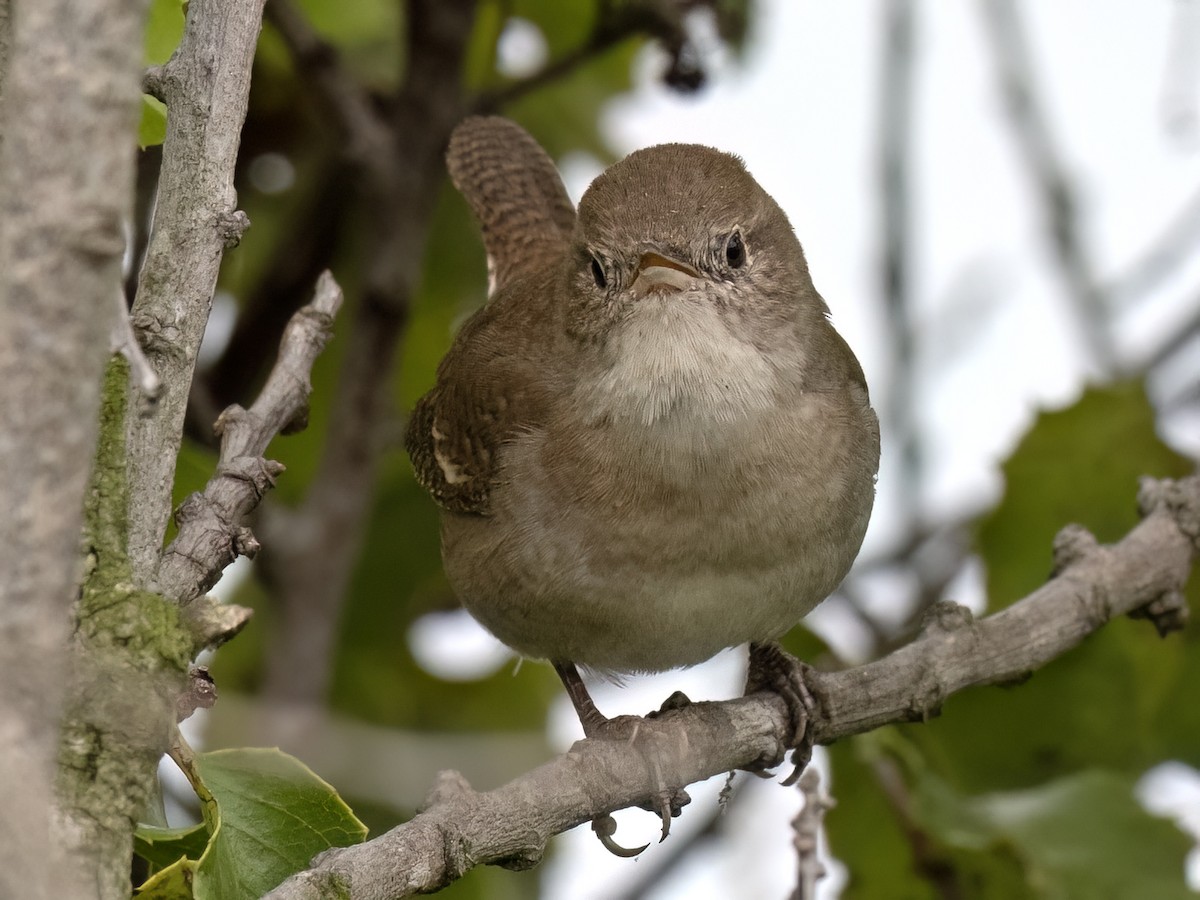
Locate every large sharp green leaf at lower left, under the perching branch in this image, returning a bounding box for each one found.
[196,748,366,900]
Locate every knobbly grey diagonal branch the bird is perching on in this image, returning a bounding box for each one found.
[269,475,1200,900]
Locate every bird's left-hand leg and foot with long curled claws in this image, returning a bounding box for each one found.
[553,660,691,857]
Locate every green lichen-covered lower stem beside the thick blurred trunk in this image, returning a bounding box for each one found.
[59,356,193,896]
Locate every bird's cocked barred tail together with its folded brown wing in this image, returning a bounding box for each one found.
[404,116,575,516]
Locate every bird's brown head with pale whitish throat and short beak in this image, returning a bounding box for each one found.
[565,144,827,421]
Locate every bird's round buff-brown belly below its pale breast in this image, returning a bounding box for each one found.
[443,405,874,672]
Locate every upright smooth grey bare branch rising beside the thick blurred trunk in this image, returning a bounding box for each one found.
[127,0,263,586]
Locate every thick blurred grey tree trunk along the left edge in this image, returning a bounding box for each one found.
[0,0,145,898]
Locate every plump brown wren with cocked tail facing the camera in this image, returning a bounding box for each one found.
[404,116,880,849]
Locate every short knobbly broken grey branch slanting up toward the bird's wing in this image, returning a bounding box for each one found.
[158,271,342,605]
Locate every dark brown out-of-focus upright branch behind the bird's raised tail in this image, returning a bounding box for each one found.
[259,0,475,702]
